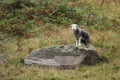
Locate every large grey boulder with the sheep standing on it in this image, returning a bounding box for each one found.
[24,45,101,69]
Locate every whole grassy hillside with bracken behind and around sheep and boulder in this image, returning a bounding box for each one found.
[0,0,120,80]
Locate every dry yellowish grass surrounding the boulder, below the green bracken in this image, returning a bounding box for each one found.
[0,27,120,80]
